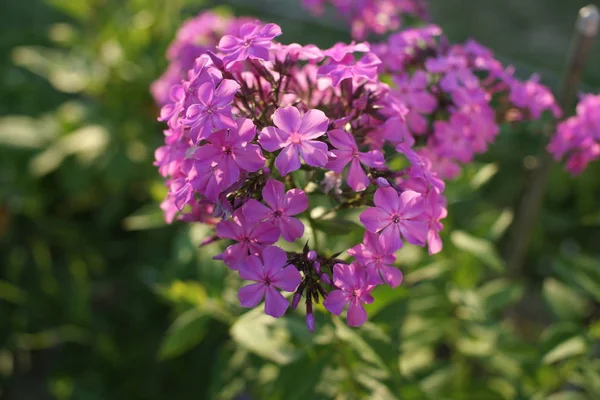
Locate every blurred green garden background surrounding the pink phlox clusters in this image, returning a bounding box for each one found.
[0,0,600,400]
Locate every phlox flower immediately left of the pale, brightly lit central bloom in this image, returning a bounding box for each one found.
[194,119,265,189]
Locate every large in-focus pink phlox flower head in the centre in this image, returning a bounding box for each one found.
[155,22,446,330]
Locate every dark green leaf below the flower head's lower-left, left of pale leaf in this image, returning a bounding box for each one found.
[159,309,212,360]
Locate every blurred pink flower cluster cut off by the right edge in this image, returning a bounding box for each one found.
[548,94,600,174]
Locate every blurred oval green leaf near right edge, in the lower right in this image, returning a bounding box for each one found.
[543,278,592,320]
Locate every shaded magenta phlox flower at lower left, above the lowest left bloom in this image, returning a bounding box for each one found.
[213,208,279,270]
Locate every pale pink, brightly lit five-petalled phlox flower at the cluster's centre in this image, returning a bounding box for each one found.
[259,106,329,176]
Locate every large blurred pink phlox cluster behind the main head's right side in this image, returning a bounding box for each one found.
[374,25,561,179]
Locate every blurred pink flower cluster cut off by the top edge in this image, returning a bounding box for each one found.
[303,0,429,40]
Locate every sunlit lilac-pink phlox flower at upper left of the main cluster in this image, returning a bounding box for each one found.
[183,79,240,143]
